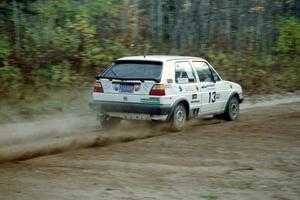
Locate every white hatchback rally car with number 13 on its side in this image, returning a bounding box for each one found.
[90,56,244,131]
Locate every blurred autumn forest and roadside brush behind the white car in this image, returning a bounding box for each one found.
[0,0,300,123]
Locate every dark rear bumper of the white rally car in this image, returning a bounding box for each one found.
[89,101,172,115]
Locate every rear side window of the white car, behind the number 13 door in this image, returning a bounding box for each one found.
[175,61,196,83]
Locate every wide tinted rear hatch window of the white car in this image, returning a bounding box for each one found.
[101,61,162,80]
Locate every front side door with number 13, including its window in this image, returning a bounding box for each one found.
[192,61,221,114]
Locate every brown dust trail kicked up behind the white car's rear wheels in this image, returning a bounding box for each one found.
[0,116,167,162]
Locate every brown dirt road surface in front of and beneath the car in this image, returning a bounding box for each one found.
[0,103,300,200]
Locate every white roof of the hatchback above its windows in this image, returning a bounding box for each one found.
[118,55,205,62]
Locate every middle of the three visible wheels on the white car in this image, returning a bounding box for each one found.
[171,103,187,132]
